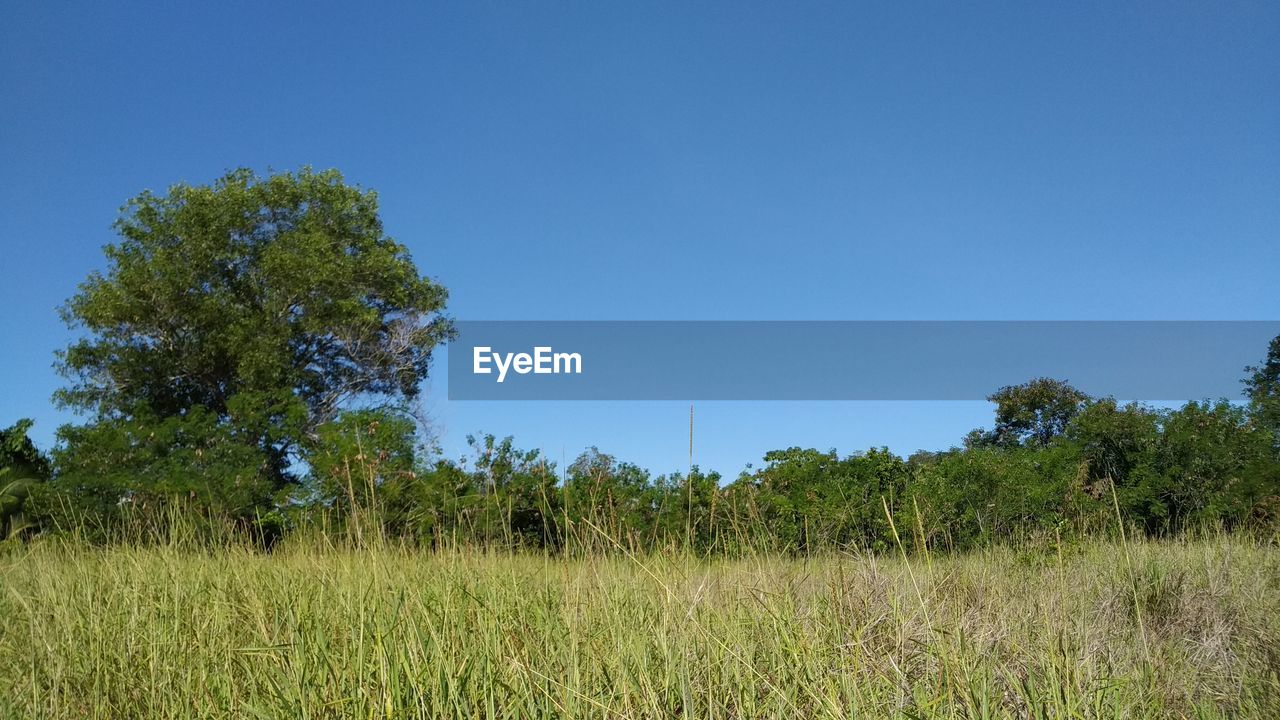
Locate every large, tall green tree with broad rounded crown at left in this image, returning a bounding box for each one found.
[56,169,452,509]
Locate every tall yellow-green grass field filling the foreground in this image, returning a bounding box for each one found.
[0,537,1280,719]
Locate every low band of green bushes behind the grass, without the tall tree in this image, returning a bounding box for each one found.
[4,361,1280,552]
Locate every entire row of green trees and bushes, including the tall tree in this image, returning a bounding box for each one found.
[0,169,1280,552]
